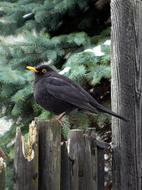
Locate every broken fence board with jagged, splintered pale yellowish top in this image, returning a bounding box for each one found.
[14,123,38,190]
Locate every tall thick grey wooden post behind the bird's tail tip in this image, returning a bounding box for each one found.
[111,0,142,190]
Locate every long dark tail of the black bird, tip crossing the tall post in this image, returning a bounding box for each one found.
[95,104,128,122]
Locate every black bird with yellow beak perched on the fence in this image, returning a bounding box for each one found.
[27,65,126,121]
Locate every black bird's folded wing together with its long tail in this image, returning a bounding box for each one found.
[44,74,126,121]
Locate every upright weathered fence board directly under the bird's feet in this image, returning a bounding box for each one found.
[37,120,61,190]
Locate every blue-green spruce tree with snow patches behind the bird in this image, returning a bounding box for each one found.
[0,0,111,189]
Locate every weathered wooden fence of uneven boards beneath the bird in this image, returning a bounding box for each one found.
[0,120,108,190]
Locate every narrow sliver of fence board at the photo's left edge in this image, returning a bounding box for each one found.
[0,157,6,190]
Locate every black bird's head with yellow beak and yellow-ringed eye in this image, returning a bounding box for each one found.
[26,65,54,76]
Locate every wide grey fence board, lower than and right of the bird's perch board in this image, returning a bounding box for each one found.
[69,130,93,190]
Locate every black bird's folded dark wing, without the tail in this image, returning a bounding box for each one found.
[44,76,97,112]
